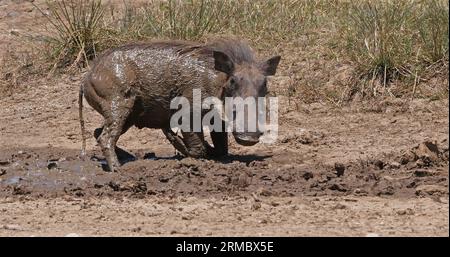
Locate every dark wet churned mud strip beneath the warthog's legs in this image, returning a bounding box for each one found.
[0,142,448,197]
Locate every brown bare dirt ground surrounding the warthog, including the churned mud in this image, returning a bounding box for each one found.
[0,1,449,236]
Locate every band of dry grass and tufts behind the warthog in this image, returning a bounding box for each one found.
[0,0,449,102]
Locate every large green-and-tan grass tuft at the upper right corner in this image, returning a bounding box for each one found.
[338,0,449,83]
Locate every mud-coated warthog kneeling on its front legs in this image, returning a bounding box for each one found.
[79,39,281,171]
